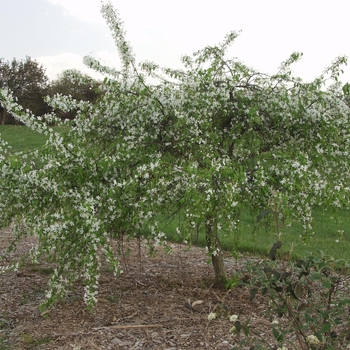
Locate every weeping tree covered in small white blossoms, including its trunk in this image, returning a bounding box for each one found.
[0,3,350,306]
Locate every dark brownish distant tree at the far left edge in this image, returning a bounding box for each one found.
[0,56,49,125]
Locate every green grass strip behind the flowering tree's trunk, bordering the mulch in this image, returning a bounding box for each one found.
[159,208,350,260]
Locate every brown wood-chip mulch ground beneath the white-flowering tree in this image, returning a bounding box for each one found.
[0,230,278,350]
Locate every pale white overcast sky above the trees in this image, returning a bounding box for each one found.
[0,0,350,81]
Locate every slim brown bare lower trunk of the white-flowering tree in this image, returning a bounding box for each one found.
[205,215,226,286]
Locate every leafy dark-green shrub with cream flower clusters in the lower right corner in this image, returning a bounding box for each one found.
[236,243,350,350]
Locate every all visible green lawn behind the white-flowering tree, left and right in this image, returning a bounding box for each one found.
[0,125,350,260]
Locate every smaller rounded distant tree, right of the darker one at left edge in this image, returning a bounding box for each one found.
[49,69,100,119]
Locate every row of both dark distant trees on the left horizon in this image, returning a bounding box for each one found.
[0,56,100,125]
